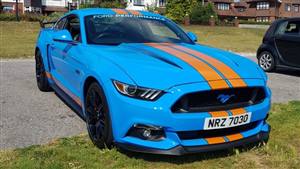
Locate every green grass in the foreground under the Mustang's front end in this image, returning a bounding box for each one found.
[0,101,300,169]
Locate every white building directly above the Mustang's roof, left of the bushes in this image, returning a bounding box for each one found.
[126,0,167,10]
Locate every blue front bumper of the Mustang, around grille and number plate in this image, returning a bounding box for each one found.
[108,80,271,155]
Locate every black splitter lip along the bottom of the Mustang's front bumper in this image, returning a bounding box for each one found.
[116,130,270,156]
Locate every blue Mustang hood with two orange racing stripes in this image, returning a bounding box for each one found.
[88,44,263,89]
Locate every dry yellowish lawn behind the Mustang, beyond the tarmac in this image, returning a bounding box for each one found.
[0,22,265,58]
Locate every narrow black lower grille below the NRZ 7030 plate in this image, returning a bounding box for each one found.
[177,122,258,140]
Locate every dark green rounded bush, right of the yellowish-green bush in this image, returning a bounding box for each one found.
[190,3,218,24]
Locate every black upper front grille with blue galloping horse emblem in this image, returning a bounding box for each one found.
[171,87,266,113]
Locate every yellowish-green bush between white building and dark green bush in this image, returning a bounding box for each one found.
[166,0,198,23]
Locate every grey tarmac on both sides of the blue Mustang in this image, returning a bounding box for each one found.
[0,57,300,149]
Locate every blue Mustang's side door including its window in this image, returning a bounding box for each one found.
[51,15,83,103]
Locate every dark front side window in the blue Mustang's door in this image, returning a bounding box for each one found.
[65,16,81,42]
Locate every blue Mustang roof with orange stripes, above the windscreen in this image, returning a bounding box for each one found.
[66,8,164,18]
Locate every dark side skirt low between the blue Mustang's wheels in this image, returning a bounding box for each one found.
[51,83,85,121]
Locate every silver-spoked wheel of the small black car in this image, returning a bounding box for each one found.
[258,51,275,72]
